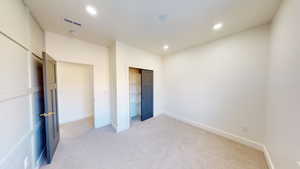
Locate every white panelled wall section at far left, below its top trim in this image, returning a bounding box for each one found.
[0,35,31,168]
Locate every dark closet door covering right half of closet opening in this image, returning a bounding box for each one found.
[141,69,153,121]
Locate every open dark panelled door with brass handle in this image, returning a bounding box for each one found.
[41,52,60,164]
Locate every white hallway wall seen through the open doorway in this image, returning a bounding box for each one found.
[57,62,94,124]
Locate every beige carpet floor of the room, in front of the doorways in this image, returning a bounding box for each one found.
[42,116,267,169]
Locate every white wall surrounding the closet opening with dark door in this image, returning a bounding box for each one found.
[112,41,163,132]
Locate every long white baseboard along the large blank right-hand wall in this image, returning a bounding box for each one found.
[165,113,265,151]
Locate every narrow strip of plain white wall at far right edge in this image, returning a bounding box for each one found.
[266,0,300,169]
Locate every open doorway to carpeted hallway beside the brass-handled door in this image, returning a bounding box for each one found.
[57,62,94,138]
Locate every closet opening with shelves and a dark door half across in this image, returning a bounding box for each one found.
[129,67,154,124]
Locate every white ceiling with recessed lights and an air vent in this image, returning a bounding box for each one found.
[25,0,281,55]
